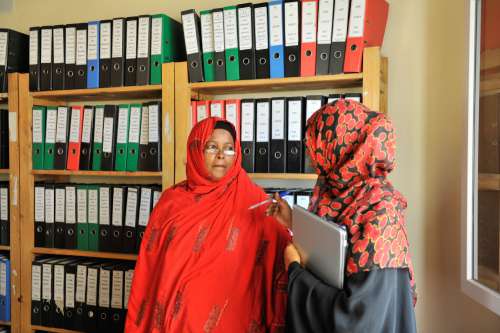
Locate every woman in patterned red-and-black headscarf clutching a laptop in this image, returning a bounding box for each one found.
[267,100,416,333]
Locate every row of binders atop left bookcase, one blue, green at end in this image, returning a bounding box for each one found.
[29,14,185,91]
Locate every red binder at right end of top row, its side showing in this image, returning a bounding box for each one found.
[344,0,389,73]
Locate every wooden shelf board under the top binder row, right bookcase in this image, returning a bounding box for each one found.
[189,73,363,95]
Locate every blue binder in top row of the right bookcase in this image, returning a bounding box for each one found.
[269,0,285,78]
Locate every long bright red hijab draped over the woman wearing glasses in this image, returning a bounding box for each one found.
[125,118,289,333]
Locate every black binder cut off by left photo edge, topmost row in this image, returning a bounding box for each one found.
[0,29,29,92]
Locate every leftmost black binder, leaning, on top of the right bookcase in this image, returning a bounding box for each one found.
[181,9,204,82]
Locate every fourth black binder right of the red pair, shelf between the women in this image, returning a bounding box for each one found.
[286,97,305,173]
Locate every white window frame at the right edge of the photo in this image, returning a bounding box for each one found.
[461,0,500,316]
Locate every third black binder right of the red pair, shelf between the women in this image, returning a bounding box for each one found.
[269,97,287,173]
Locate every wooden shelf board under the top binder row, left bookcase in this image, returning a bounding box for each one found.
[31,85,162,102]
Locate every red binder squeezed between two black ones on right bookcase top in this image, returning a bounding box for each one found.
[300,0,318,76]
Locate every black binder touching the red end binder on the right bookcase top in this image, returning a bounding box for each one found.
[328,0,350,74]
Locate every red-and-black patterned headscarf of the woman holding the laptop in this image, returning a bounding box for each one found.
[306,100,416,301]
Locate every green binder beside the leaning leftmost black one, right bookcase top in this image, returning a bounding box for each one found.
[200,10,215,82]
